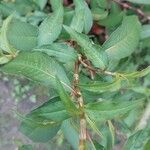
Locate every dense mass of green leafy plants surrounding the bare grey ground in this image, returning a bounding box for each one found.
[0,0,150,150]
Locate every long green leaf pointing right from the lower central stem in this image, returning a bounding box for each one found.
[85,99,143,121]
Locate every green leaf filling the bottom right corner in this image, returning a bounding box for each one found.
[123,127,150,150]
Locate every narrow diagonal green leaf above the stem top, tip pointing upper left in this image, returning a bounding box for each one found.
[64,26,107,69]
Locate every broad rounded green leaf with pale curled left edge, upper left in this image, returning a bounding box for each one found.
[0,16,38,52]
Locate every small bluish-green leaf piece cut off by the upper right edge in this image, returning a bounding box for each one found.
[141,24,150,40]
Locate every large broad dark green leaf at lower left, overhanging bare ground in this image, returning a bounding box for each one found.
[20,97,70,142]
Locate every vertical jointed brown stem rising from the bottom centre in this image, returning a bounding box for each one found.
[74,60,87,150]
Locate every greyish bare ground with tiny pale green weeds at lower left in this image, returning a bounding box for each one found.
[0,75,51,150]
